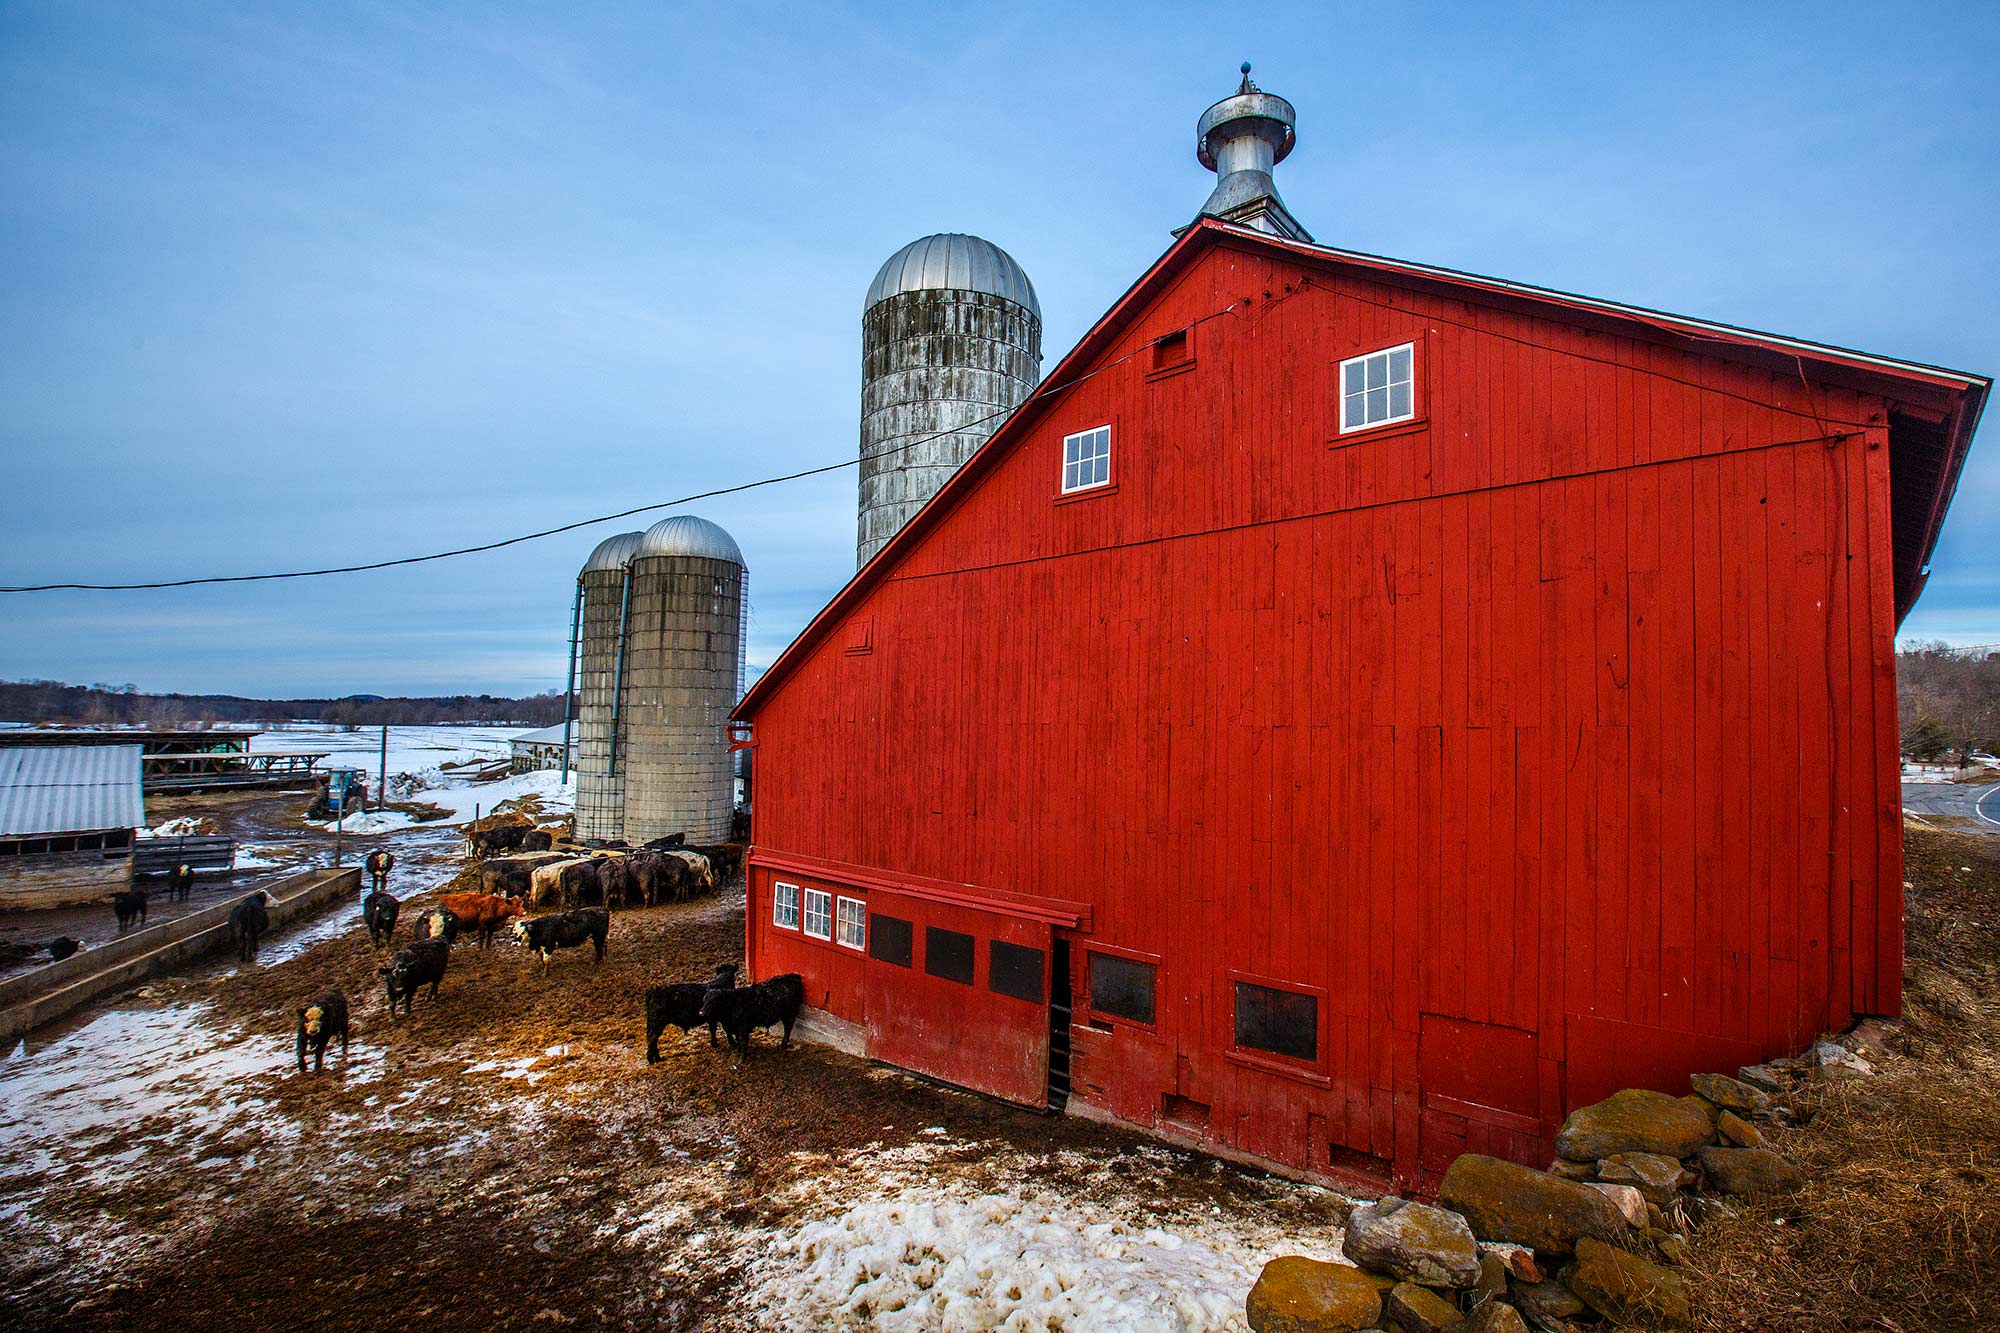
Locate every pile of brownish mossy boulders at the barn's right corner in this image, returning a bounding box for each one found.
[1246,1021,1886,1333]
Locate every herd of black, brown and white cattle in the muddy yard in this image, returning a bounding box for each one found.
[296,827,806,1071]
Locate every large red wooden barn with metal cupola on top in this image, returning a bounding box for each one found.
[736,65,1990,1187]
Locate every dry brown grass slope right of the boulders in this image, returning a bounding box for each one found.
[1684,827,2000,1333]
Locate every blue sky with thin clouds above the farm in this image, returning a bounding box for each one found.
[0,2,2000,695]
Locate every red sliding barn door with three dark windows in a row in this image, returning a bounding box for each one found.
[866,891,1050,1107]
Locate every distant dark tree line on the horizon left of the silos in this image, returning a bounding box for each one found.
[0,681,562,727]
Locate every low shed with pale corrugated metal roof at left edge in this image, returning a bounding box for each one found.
[0,745,146,909]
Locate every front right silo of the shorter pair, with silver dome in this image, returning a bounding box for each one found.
[620,514,748,843]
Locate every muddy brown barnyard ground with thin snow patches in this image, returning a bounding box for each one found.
[0,824,1346,1329]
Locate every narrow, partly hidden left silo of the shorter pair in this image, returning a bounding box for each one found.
[576,532,644,839]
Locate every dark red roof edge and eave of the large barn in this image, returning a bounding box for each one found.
[732,218,1992,719]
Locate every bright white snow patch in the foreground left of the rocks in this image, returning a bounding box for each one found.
[728,1143,1344,1333]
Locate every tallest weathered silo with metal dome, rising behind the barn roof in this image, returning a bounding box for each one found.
[854,232,1042,566]
